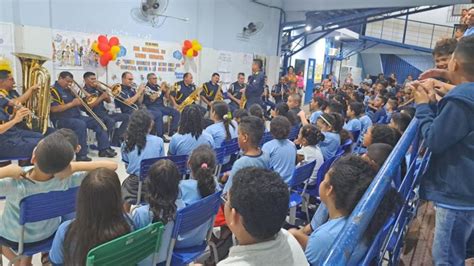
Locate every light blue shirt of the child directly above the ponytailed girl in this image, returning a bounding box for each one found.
[168,132,214,155]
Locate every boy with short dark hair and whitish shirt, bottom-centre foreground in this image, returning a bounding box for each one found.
[217,167,308,266]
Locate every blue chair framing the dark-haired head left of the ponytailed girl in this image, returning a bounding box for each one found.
[135,155,188,204]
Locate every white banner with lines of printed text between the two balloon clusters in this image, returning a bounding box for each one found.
[107,36,197,84]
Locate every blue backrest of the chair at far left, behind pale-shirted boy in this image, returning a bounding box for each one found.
[20,187,79,225]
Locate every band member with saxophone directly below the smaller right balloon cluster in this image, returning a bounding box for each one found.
[170,72,207,116]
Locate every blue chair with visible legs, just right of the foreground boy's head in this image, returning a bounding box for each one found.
[288,160,316,224]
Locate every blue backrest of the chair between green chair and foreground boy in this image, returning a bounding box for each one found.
[171,191,221,239]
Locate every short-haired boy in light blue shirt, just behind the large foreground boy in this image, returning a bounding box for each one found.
[222,116,270,192]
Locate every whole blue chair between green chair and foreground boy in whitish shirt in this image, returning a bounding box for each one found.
[166,191,221,266]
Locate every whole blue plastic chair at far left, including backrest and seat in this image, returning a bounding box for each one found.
[4,187,79,264]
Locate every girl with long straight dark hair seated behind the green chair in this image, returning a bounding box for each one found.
[49,168,133,265]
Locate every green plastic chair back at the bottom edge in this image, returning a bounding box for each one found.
[86,222,164,266]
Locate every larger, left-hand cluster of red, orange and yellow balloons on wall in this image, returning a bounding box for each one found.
[92,35,127,67]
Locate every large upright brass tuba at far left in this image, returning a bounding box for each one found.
[14,53,51,134]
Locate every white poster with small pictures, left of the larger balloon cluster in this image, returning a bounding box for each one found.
[51,30,99,72]
